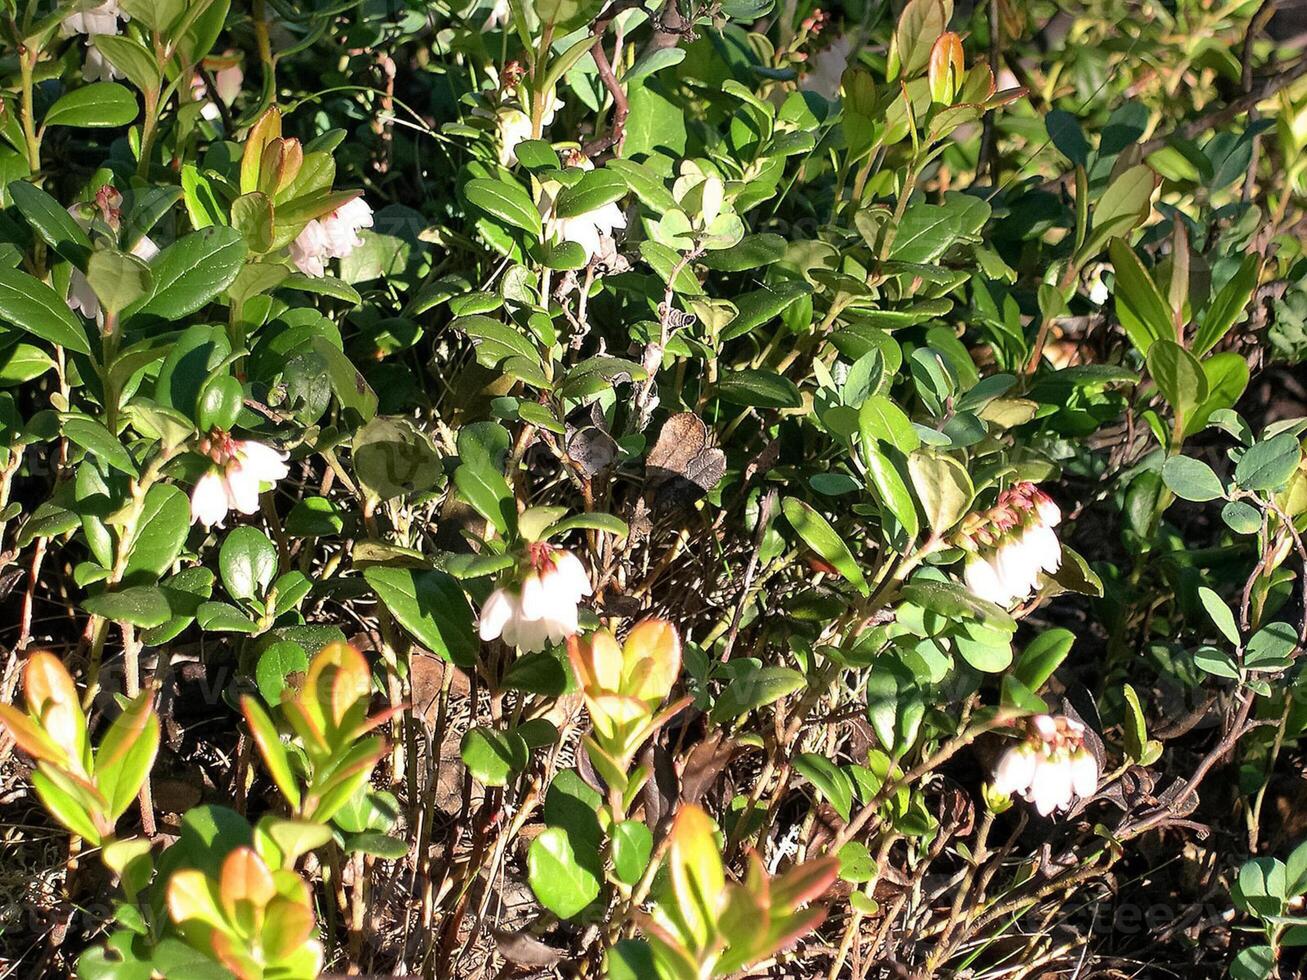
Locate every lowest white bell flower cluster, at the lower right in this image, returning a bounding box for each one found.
[993,715,1098,817]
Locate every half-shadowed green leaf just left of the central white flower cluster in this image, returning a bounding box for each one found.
[363,566,480,668]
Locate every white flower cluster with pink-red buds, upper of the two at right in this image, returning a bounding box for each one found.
[959,483,1061,608]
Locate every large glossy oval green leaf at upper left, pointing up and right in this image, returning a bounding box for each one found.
[124,226,247,321]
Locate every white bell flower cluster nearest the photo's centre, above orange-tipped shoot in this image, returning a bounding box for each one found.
[478,541,591,652]
